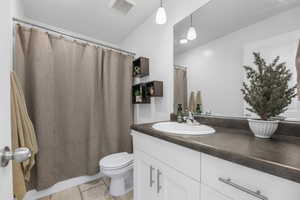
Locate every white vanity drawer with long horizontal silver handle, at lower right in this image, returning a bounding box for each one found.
[201,154,300,200]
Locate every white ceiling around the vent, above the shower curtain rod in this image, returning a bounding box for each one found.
[17,0,159,44]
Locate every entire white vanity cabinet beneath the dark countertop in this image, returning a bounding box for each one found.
[132,131,300,200]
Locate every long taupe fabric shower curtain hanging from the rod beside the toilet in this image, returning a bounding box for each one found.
[14,25,133,190]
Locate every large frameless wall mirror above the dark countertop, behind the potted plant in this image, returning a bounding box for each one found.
[174,0,300,121]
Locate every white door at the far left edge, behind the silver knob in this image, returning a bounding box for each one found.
[0,0,12,200]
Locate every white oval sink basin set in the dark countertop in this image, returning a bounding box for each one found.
[152,122,216,135]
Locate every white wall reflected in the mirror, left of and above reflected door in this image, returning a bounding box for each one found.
[175,8,300,116]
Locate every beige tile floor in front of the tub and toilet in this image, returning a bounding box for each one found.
[39,178,133,200]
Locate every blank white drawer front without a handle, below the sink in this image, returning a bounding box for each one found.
[131,131,201,181]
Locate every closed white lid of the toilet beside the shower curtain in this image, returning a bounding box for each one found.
[100,152,133,168]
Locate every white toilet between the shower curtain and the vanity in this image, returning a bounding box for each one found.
[99,152,133,197]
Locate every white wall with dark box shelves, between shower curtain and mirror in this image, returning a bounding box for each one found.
[120,0,209,123]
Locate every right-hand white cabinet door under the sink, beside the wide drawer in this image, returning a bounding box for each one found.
[155,158,200,200]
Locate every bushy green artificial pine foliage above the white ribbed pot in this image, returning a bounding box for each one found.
[241,53,297,120]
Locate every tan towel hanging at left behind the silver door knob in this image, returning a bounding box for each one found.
[10,72,38,200]
